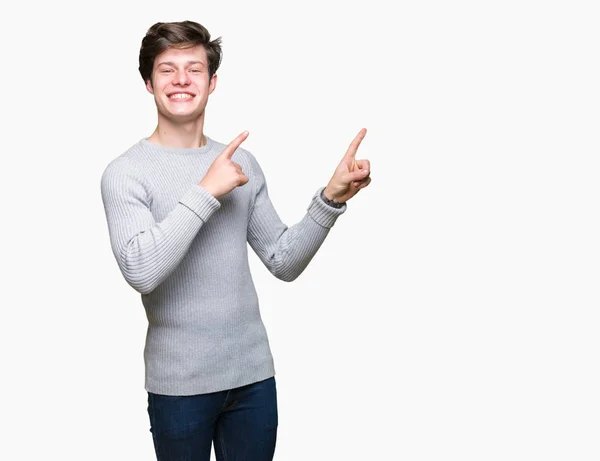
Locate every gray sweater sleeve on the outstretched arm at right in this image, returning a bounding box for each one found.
[246,151,347,282]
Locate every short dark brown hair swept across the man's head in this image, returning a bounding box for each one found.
[139,21,223,83]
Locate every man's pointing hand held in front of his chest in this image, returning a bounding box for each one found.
[199,131,248,198]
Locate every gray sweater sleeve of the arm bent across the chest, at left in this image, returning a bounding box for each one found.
[101,156,221,294]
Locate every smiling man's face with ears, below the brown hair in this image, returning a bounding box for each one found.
[146,45,217,123]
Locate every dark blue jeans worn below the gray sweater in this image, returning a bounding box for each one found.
[148,376,278,461]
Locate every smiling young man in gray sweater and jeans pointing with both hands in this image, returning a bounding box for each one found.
[101,21,371,461]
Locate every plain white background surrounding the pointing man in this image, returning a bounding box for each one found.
[0,0,600,461]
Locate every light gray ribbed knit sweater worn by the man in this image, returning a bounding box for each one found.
[101,137,347,395]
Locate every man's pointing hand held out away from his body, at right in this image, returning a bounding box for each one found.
[323,128,371,202]
